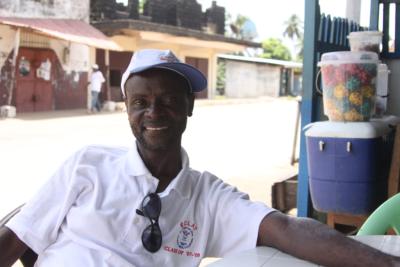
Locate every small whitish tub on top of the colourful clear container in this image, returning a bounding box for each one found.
[347,31,382,54]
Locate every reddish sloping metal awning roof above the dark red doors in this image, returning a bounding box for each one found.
[0,17,122,51]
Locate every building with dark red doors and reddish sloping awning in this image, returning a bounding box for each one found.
[0,0,118,113]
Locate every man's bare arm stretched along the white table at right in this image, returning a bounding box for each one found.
[257,212,400,267]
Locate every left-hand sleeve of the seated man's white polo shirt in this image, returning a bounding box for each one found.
[6,150,90,254]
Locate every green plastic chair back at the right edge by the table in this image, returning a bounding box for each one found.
[357,193,400,236]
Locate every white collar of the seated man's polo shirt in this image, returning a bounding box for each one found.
[125,142,191,198]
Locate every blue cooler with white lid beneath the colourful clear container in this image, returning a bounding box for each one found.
[305,120,392,215]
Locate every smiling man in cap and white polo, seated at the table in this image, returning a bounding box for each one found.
[0,50,400,267]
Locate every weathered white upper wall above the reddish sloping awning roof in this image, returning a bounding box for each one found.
[0,0,90,22]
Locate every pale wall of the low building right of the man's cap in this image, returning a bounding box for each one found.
[225,60,280,98]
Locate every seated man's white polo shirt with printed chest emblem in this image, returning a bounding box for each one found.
[6,145,273,267]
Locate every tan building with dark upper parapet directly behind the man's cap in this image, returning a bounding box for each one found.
[91,0,260,101]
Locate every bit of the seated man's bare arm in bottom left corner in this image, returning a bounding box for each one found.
[0,226,28,267]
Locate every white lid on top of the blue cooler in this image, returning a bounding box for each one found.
[304,121,390,139]
